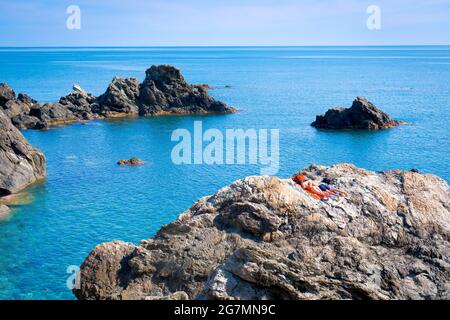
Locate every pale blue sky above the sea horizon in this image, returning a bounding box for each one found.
[0,0,450,46]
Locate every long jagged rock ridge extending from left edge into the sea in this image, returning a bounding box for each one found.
[0,65,235,130]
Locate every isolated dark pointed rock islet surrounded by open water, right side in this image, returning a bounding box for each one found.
[311,97,401,130]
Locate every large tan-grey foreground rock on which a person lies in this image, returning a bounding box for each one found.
[74,164,450,300]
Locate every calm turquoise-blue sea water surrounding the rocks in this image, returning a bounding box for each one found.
[0,47,450,299]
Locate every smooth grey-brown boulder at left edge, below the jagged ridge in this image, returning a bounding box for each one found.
[0,111,45,196]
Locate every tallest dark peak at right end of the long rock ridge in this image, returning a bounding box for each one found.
[138,65,235,115]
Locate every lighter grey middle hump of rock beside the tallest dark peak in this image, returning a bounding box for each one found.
[94,77,139,118]
